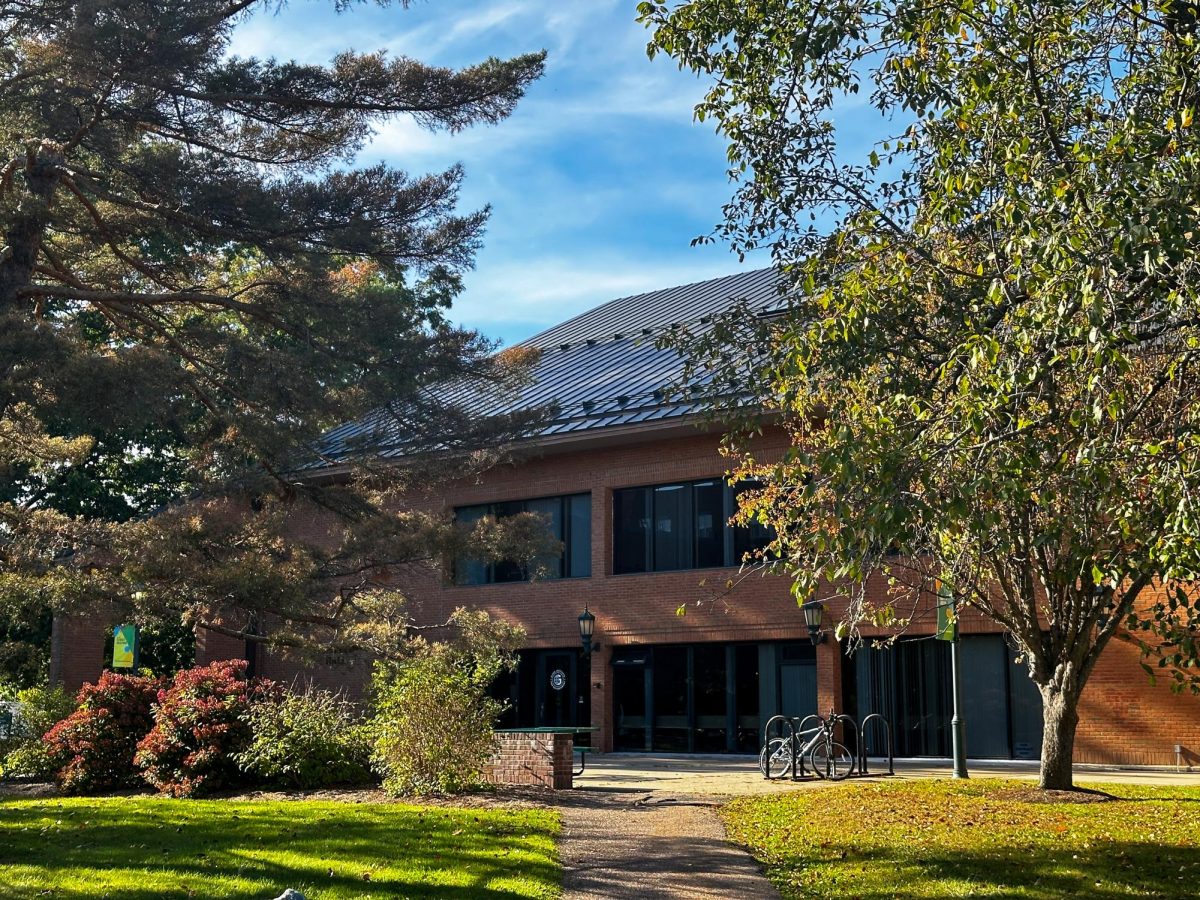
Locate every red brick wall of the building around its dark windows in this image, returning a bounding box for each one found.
[64,431,1200,764]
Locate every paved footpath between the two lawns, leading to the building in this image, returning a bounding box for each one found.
[558,790,779,900]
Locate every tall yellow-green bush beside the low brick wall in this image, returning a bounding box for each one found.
[374,608,522,794]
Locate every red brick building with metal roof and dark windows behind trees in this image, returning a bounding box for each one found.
[51,271,1200,764]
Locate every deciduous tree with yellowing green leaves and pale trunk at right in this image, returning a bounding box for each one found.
[641,0,1200,788]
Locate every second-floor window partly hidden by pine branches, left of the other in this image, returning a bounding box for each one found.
[455,493,592,584]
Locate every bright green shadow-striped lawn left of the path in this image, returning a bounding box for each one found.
[0,798,560,900]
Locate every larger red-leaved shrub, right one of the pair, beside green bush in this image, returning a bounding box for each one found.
[134,660,278,797]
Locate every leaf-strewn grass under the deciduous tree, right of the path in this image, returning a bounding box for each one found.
[724,781,1200,898]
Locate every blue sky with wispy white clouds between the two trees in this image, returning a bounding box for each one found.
[232,0,766,343]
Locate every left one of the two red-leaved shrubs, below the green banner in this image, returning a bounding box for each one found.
[42,672,162,793]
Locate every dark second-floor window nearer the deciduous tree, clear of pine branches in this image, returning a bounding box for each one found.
[612,478,772,575]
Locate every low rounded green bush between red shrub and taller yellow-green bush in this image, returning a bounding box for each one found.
[234,688,372,788]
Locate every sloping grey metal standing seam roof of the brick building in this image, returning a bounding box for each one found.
[318,269,781,464]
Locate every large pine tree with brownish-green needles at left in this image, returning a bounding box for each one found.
[0,0,544,662]
